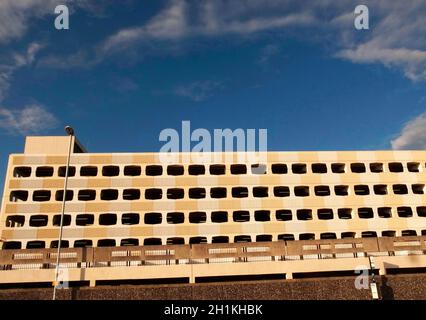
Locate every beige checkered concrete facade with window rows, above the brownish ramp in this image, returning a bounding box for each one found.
[0,137,426,249]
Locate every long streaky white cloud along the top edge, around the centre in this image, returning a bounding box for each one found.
[101,0,315,53]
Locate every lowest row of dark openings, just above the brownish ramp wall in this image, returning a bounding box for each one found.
[3,230,426,249]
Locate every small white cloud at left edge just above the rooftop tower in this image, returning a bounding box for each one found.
[0,104,58,135]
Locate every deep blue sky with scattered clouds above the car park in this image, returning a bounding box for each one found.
[0,0,426,198]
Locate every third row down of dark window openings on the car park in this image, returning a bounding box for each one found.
[6,206,426,228]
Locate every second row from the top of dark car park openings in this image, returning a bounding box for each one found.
[10,184,425,202]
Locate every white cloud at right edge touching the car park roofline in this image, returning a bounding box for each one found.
[391,112,426,150]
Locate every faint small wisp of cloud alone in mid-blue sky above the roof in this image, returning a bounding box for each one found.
[174,80,223,102]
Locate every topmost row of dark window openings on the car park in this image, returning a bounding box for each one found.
[13,162,421,178]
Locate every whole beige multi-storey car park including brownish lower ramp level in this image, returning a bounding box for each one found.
[0,137,426,285]
